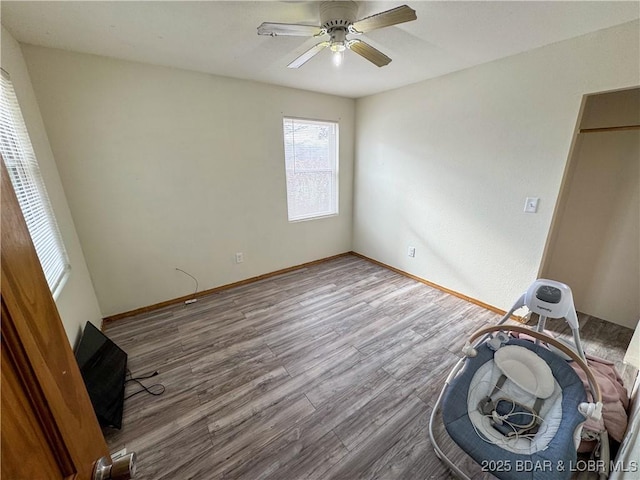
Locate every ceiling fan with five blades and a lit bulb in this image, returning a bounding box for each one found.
[258,1,417,68]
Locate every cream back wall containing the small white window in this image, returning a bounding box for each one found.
[23,46,355,316]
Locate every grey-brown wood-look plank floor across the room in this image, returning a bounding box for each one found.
[105,255,631,480]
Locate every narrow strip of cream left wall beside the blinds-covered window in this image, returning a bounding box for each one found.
[2,27,102,346]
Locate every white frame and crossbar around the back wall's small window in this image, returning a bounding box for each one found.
[282,115,340,223]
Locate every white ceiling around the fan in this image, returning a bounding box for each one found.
[1,0,640,98]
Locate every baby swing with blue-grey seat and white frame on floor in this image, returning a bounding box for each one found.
[429,279,609,480]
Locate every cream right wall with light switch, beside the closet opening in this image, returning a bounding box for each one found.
[354,22,640,316]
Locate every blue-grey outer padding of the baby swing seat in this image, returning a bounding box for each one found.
[442,339,586,480]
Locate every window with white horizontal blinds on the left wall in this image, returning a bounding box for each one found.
[0,70,70,296]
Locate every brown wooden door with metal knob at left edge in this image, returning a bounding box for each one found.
[0,162,109,480]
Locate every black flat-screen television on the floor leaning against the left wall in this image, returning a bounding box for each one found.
[75,322,127,428]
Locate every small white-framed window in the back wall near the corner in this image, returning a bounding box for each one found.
[283,118,338,221]
